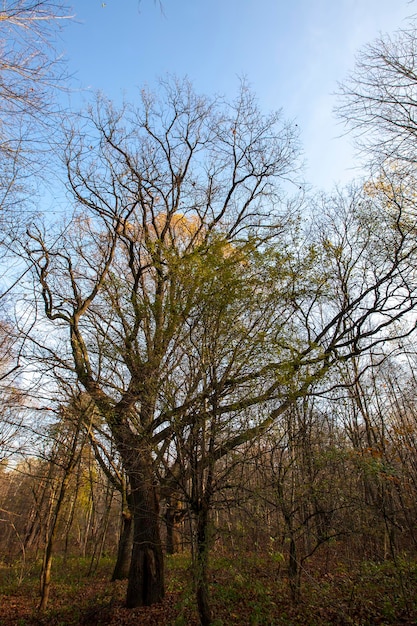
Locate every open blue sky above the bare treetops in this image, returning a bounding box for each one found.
[59,0,417,189]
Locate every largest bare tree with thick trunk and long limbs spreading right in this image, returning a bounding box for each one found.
[26,80,417,623]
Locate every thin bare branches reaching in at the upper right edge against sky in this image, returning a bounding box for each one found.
[337,19,417,178]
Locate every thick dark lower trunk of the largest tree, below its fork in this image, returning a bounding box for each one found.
[126,464,165,608]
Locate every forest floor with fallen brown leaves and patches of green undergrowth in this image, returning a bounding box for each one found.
[0,554,417,626]
